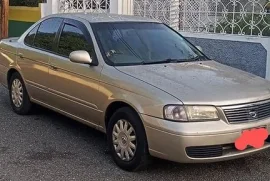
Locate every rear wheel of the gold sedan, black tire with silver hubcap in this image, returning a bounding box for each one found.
[9,72,32,115]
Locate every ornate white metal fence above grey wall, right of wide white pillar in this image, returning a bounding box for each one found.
[134,0,270,36]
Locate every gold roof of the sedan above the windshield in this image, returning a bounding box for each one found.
[51,13,159,23]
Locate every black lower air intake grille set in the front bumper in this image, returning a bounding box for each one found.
[186,145,223,158]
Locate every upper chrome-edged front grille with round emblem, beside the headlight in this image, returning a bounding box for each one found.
[223,100,270,123]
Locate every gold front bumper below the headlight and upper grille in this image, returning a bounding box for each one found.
[141,115,270,163]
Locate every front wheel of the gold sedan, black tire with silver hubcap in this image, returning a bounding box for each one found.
[107,107,149,171]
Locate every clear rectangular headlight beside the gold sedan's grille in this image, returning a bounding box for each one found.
[164,105,219,121]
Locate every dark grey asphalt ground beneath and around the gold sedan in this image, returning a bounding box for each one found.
[0,86,270,181]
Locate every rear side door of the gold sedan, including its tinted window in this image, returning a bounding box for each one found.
[17,18,63,103]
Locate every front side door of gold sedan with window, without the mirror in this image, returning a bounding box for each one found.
[48,19,102,126]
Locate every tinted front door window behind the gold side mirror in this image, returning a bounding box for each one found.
[58,24,94,57]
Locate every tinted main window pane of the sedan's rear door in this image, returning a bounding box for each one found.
[34,18,62,51]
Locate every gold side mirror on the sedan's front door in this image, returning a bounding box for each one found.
[69,50,93,64]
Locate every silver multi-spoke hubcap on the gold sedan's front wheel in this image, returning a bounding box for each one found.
[112,119,137,161]
